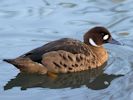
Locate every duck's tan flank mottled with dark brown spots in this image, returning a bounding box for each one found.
[42,47,106,73]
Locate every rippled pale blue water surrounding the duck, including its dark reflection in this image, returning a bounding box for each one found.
[0,0,133,100]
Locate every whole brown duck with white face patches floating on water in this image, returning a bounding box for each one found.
[4,27,119,74]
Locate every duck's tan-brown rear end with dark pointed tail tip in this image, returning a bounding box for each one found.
[3,58,47,74]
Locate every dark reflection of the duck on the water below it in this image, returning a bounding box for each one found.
[4,65,121,90]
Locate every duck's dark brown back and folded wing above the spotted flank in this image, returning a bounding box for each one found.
[20,38,89,62]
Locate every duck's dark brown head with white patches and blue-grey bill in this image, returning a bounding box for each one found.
[84,27,120,47]
